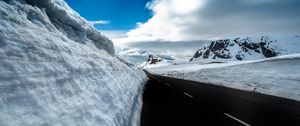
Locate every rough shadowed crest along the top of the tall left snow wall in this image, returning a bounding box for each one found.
[26,0,114,55]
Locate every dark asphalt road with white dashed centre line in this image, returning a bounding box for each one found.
[141,72,300,126]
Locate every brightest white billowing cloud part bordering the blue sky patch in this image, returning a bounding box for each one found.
[120,0,204,42]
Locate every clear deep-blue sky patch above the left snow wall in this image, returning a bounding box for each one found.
[65,0,151,31]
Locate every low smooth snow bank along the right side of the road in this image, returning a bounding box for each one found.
[148,54,300,101]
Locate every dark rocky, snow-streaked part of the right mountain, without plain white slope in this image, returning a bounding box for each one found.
[190,36,279,61]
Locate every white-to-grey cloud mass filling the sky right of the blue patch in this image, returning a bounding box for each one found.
[115,0,300,43]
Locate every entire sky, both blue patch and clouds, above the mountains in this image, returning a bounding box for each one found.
[66,0,300,44]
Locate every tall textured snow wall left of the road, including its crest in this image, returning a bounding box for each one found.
[0,0,147,126]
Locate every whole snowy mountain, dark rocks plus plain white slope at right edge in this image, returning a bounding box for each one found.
[190,36,300,62]
